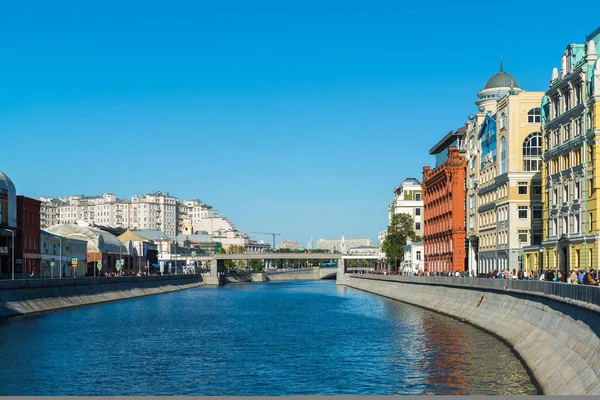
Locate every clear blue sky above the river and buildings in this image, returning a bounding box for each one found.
[0,0,600,243]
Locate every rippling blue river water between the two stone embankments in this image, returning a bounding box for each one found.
[0,281,536,396]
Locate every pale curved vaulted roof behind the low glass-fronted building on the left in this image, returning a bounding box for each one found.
[46,224,128,254]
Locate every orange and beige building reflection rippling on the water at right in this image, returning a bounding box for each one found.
[387,300,538,395]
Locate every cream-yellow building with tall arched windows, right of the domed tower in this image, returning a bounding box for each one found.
[476,91,543,274]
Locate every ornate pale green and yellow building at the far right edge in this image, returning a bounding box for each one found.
[525,28,600,278]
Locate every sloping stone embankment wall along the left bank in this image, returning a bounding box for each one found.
[0,275,204,317]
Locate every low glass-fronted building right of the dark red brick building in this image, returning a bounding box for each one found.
[38,228,88,278]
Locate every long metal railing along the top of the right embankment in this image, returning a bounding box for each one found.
[348,274,600,307]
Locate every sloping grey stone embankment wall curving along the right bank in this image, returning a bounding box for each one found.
[338,275,600,395]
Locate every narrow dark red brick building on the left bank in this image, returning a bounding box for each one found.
[15,196,41,276]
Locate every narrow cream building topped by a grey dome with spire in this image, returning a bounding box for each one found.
[465,59,523,273]
